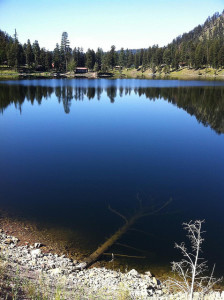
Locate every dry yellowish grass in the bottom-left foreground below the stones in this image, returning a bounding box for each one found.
[0,256,131,300]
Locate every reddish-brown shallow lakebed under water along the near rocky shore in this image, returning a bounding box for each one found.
[0,210,172,280]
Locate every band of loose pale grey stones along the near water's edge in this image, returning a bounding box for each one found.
[0,229,224,300]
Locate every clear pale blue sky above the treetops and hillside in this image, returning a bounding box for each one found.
[0,0,224,50]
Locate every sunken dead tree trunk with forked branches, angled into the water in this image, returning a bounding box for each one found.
[76,196,172,270]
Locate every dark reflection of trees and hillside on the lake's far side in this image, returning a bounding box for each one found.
[0,84,224,134]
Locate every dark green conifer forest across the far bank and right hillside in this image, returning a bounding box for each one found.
[0,11,224,73]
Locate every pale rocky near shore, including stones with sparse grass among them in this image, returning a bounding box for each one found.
[0,229,224,300]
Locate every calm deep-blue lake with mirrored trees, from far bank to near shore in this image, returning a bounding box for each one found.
[0,79,224,274]
